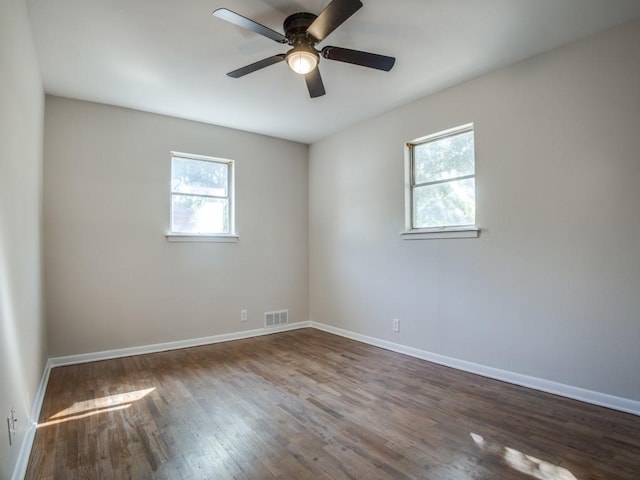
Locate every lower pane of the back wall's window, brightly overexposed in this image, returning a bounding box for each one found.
[171,194,229,233]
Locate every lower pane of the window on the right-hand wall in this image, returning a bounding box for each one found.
[413,178,476,228]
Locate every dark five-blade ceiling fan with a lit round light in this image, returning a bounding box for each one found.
[213,0,396,98]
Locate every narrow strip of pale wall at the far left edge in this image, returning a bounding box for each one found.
[0,0,47,479]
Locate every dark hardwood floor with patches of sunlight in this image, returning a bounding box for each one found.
[26,329,640,480]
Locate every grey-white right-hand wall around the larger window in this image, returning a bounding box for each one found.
[309,22,640,400]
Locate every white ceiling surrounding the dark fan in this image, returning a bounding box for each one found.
[27,0,640,143]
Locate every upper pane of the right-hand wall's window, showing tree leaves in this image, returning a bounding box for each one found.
[413,131,475,184]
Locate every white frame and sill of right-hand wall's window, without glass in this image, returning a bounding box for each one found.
[401,123,480,240]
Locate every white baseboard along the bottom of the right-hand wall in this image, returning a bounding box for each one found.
[309,321,640,415]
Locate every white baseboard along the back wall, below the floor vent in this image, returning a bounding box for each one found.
[49,322,309,368]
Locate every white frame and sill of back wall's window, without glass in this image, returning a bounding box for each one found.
[166,151,239,243]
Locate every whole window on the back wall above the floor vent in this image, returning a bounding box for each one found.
[169,152,235,236]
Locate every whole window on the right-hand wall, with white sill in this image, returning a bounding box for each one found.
[405,124,477,238]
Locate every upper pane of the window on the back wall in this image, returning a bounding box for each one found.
[171,157,229,197]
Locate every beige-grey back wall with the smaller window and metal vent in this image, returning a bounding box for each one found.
[44,96,308,356]
